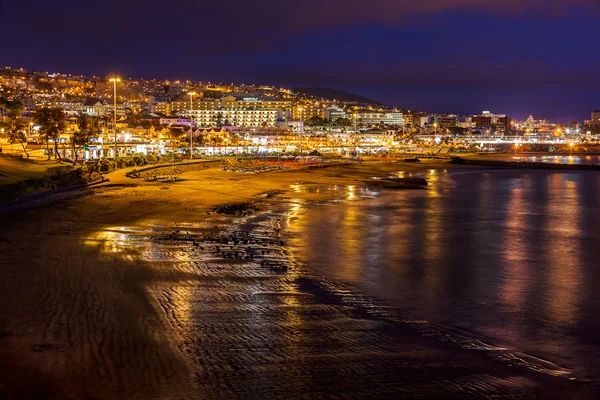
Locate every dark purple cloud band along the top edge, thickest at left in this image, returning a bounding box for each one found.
[0,0,600,54]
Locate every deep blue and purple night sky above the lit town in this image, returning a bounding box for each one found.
[0,0,600,120]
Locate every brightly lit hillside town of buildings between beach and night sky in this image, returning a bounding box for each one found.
[0,65,599,159]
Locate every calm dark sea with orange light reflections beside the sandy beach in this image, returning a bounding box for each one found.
[287,170,600,382]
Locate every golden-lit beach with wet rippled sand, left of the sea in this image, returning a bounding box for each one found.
[0,162,594,399]
